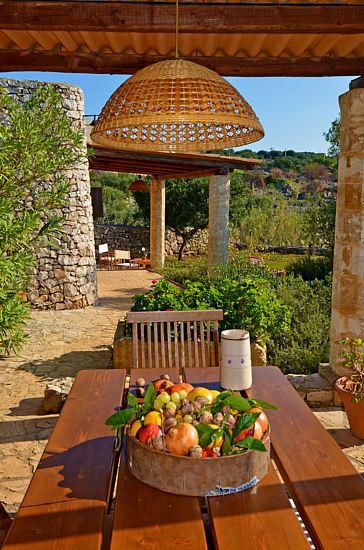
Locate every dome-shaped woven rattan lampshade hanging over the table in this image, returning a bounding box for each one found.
[91,59,264,152]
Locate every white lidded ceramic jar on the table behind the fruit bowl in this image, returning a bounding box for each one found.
[220,329,252,390]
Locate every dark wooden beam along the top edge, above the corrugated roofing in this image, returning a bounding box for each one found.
[0,0,364,34]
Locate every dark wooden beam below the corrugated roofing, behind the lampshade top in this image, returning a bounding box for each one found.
[0,50,364,76]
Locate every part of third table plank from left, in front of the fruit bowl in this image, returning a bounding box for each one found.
[208,463,309,550]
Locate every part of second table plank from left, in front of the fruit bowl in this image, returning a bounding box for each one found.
[111,454,207,550]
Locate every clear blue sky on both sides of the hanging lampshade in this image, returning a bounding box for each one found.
[0,72,354,152]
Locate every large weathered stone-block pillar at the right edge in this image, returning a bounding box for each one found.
[330,78,364,378]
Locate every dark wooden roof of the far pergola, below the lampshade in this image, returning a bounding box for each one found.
[89,143,261,180]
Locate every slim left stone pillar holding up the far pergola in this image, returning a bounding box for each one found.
[150,179,166,269]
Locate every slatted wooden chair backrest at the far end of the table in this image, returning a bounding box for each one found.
[126,309,224,372]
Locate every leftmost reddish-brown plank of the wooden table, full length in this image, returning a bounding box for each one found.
[3,370,125,550]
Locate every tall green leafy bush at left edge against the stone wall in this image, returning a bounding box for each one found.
[0,85,83,353]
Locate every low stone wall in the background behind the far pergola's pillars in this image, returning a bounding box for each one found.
[95,225,208,258]
